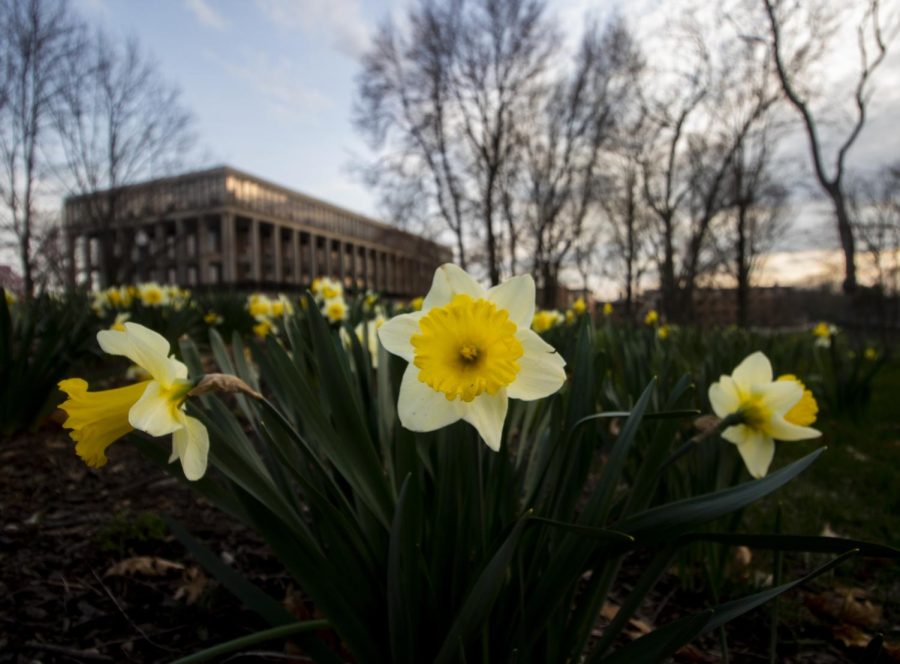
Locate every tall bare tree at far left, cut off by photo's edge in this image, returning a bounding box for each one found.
[0,0,79,297]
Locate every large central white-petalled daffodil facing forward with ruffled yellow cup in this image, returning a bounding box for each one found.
[378,263,566,451]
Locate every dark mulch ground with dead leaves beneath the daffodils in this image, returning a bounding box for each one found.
[0,425,900,664]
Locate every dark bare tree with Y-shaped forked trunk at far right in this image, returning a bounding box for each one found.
[762,0,893,293]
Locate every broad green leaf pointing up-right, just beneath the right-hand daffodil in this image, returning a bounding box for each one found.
[616,447,825,544]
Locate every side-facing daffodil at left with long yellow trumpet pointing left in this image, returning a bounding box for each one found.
[59,323,209,480]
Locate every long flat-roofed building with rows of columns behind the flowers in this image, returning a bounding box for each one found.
[64,166,452,297]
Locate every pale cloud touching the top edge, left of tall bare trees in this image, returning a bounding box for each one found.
[256,0,369,59]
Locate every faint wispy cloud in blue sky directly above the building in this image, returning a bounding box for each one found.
[203,49,334,123]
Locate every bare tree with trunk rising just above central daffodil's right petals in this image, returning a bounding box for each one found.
[516,20,642,307]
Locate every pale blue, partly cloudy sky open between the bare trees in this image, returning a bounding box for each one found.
[74,0,900,296]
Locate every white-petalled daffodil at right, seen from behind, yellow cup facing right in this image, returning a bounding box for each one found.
[709,351,822,478]
